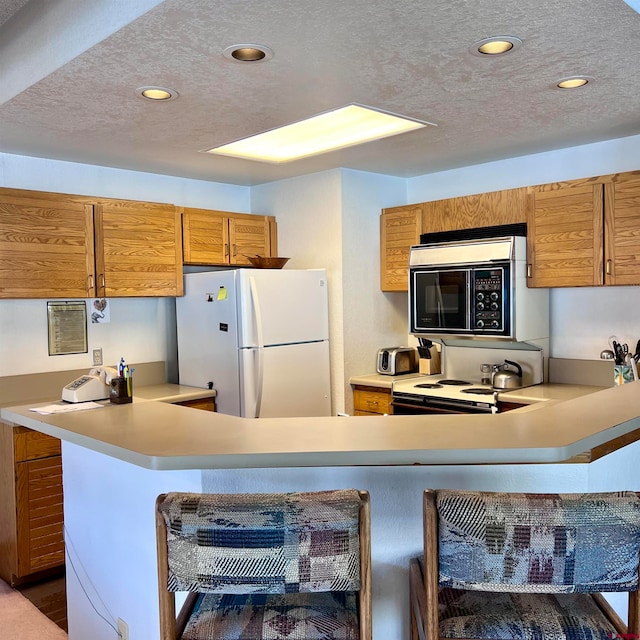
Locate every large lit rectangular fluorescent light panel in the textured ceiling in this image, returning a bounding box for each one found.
[207,104,431,163]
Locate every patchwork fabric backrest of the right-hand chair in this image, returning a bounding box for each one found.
[436,491,640,593]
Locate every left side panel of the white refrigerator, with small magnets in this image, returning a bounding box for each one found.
[176,271,240,416]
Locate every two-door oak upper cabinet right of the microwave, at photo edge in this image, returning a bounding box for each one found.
[527,171,640,287]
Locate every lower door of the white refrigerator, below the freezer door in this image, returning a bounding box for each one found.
[239,341,331,418]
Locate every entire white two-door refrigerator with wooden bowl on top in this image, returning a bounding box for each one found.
[176,269,331,418]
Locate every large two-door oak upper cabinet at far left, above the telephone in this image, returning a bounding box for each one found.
[0,189,182,298]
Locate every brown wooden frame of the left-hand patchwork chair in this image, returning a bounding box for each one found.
[156,491,373,640]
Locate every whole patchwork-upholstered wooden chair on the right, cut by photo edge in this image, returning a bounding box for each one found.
[410,490,640,640]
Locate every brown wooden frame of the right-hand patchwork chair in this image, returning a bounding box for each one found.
[409,489,640,640]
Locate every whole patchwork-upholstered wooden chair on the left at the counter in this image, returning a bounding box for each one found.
[157,490,371,640]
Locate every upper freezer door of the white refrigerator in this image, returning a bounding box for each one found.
[238,269,329,348]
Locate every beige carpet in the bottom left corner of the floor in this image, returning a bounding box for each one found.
[0,580,68,640]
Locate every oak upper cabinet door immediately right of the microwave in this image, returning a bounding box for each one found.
[527,180,604,287]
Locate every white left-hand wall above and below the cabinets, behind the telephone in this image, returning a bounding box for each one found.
[0,154,250,377]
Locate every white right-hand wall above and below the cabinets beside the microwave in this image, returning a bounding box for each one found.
[408,136,640,360]
